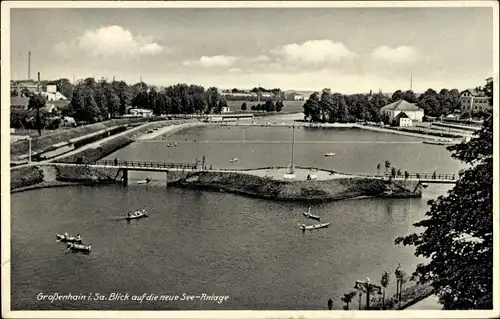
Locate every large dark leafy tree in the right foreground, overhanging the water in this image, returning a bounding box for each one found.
[396,116,493,310]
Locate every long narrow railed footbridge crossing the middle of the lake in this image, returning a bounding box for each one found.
[63,160,458,186]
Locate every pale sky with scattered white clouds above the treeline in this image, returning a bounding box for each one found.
[10,7,493,93]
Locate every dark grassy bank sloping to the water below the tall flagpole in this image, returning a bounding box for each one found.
[173,171,421,201]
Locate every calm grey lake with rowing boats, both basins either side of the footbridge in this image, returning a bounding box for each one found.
[11,127,463,310]
